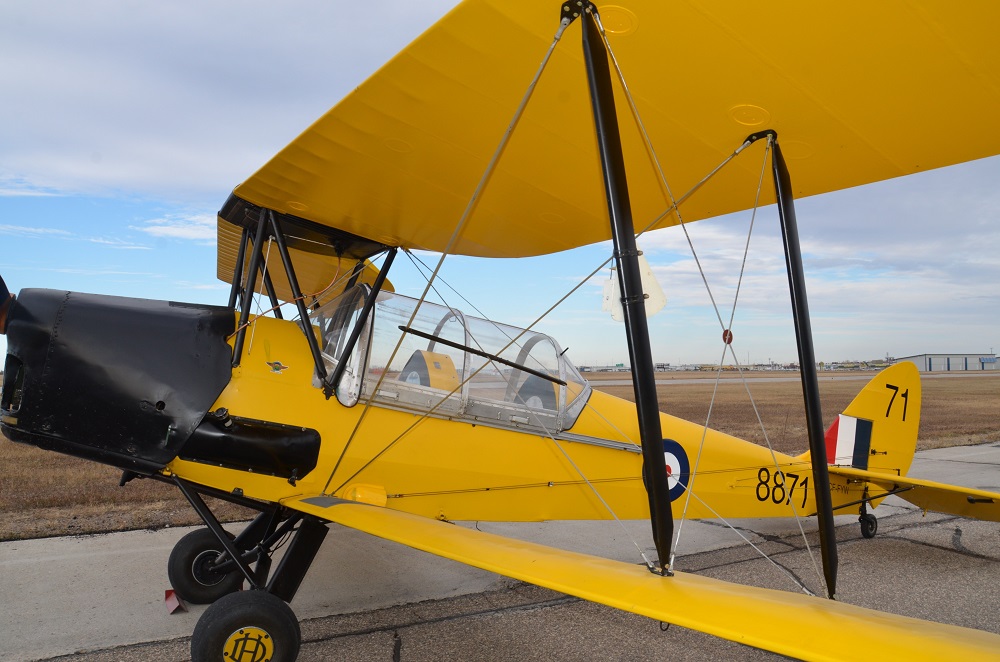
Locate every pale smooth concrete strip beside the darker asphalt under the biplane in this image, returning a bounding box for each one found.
[0,443,1000,660]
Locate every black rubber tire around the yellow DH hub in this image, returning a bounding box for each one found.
[191,590,302,662]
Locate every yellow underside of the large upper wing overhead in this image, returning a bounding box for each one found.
[235,0,1000,257]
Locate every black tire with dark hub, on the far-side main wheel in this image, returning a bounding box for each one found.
[167,529,244,605]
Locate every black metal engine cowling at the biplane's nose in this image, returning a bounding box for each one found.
[0,289,235,472]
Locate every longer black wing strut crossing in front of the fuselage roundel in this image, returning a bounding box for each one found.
[580,2,672,574]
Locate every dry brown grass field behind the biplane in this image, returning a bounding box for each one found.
[0,372,1000,540]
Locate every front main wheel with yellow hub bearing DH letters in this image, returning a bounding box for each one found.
[191,590,302,662]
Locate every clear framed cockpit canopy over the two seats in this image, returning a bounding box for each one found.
[310,285,590,432]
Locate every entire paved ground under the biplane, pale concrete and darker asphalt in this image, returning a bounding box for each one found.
[0,442,1000,662]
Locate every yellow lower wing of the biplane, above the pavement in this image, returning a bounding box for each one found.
[283,496,1000,660]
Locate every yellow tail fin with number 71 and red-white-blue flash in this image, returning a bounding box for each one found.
[826,361,920,476]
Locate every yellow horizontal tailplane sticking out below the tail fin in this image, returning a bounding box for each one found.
[829,467,1000,522]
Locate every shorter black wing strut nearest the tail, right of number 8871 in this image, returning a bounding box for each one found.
[760,131,837,598]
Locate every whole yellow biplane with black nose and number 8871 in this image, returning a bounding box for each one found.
[0,0,1000,661]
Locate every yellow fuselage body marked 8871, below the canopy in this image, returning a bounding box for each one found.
[167,318,856,521]
